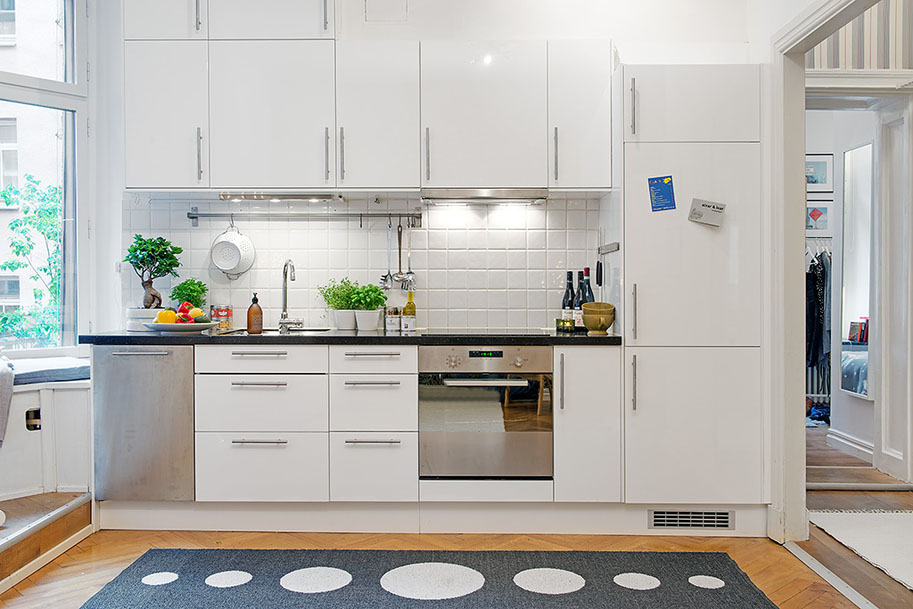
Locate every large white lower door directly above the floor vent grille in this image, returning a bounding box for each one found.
[628,347,763,504]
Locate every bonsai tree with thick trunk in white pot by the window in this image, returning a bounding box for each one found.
[124,235,184,332]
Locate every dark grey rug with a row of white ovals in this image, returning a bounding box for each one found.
[82,550,776,609]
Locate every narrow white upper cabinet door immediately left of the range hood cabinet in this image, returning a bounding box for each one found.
[336,40,421,188]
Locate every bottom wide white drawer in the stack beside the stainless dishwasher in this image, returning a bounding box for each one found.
[195,432,329,501]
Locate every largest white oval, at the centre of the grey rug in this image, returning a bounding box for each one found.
[380,562,485,601]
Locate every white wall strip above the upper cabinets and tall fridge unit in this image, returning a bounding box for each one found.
[346,0,749,63]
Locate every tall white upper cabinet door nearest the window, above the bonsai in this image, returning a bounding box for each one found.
[124,40,209,188]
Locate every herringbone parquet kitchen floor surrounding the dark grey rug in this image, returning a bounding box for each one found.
[0,531,855,609]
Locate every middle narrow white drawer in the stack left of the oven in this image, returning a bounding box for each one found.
[330,374,418,431]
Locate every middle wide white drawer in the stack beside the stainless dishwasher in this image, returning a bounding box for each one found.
[194,374,328,431]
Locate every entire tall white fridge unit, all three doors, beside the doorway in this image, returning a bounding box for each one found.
[622,66,764,504]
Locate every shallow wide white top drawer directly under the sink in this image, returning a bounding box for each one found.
[194,345,327,374]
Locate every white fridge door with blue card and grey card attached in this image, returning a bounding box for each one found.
[624,143,761,346]
